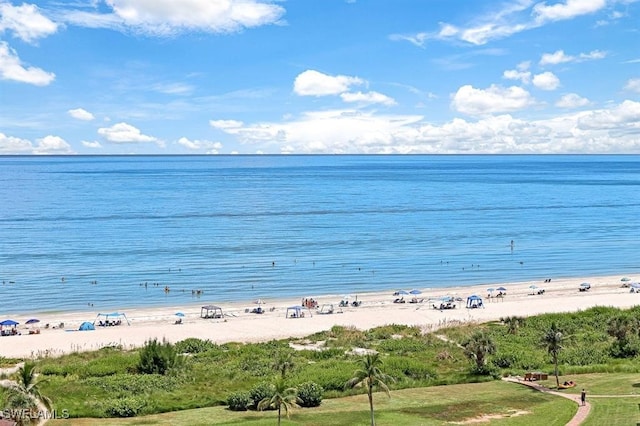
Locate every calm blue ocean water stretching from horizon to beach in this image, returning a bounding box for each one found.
[0,156,640,316]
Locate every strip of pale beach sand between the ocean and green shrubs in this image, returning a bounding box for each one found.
[0,276,640,358]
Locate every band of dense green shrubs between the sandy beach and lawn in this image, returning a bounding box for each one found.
[0,307,640,425]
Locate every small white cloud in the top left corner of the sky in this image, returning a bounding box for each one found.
[0,2,58,43]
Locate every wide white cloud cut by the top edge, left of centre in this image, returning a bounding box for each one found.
[65,0,285,36]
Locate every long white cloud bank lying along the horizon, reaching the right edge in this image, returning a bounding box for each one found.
[212,97,640,154]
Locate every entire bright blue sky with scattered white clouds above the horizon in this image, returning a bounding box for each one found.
[0,0,640,155]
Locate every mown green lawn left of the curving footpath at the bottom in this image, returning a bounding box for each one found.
[48,381,577,426]
